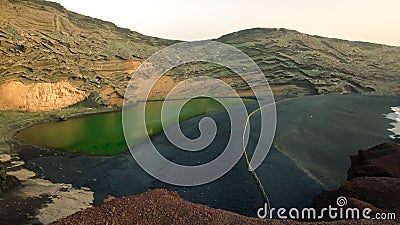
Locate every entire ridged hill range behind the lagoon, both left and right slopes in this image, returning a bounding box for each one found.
[0,0,400,111]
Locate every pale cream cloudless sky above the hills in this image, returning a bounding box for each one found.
[52,0,400,46]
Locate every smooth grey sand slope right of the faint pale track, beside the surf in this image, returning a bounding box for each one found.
[270,95,400,189]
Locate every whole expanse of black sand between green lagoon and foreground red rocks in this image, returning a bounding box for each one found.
[14,95,400,219]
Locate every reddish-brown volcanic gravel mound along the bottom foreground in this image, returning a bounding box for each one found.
[52,189,388,225]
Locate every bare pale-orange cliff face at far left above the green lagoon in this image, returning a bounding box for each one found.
[0,81,86,111]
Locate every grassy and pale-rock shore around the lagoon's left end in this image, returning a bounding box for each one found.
[0,106,118,224]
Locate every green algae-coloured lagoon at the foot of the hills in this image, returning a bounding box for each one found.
[17,98,250,155]
